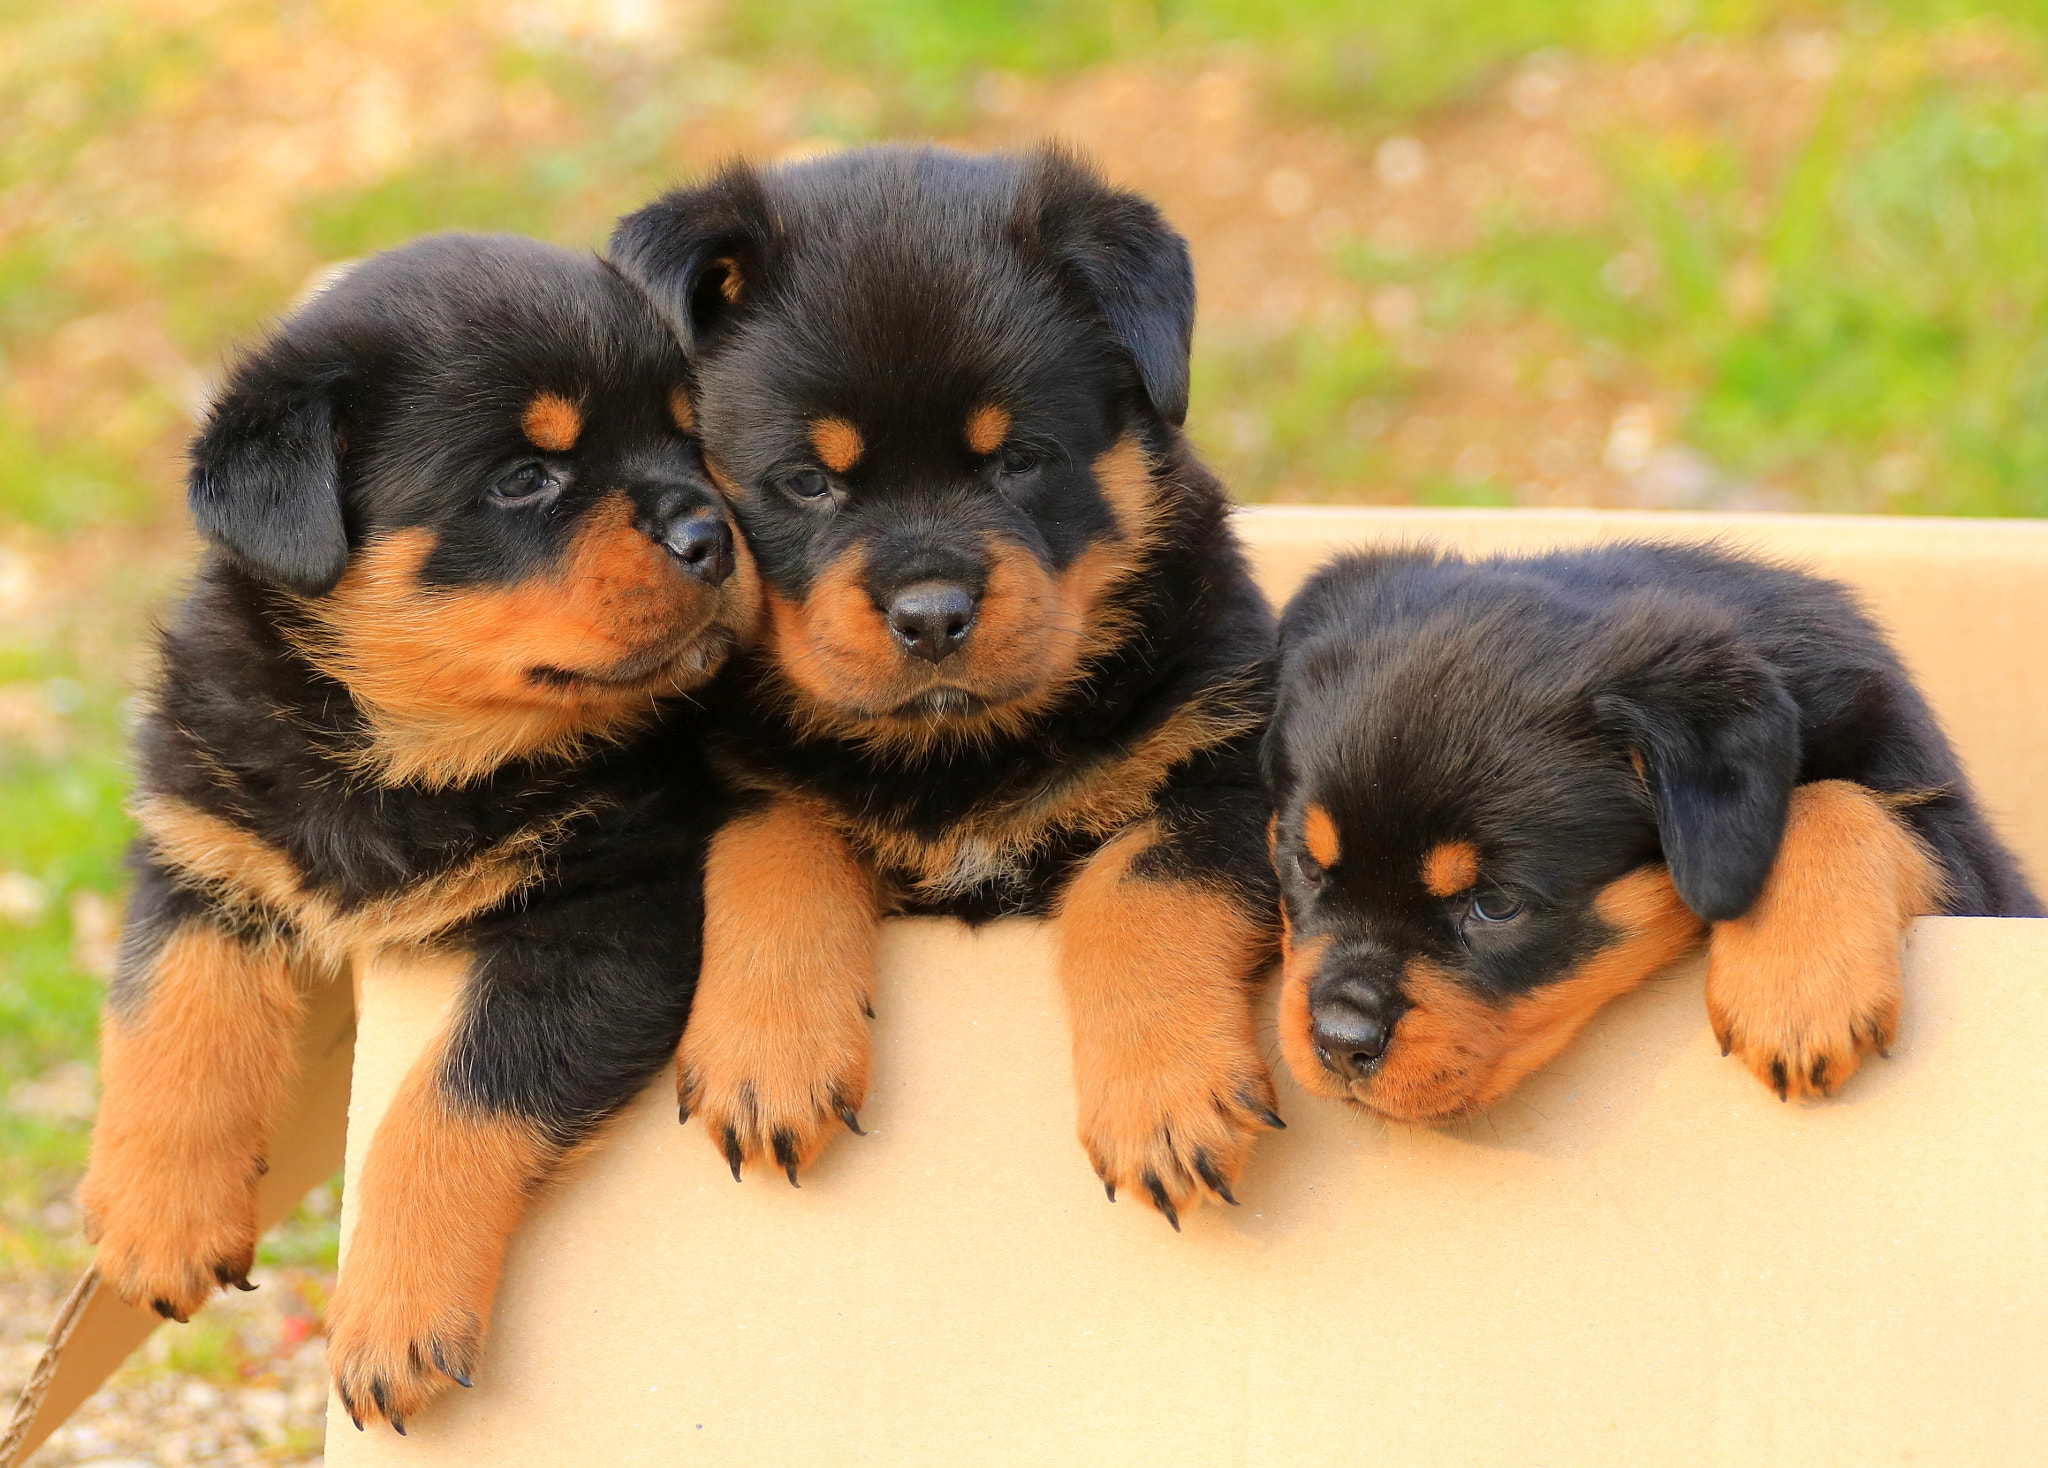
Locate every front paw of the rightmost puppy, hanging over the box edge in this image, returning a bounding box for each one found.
[1706,952,1903,1102]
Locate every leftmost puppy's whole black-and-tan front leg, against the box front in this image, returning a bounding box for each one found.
[328,872,698,1431]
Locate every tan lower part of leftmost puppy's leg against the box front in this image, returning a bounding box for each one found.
[328,1023,561,1423]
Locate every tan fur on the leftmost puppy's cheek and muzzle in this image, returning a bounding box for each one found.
[284,493,758,788]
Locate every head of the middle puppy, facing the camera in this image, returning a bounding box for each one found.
[612,149,1194,747]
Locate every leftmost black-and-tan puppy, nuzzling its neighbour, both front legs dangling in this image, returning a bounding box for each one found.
[82,235,758,1431]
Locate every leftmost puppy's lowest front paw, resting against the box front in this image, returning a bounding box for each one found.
[328,1269,489,1433]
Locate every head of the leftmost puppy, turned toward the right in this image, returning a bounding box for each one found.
[190,235,758,784]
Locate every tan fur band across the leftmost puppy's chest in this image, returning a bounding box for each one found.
[131,796,592,960]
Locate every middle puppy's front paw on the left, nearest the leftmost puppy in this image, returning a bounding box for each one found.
[676,1005,868,1185]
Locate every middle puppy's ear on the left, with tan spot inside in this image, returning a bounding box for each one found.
[606,162,774,356]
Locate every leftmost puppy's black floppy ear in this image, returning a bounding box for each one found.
[186,343,348,596]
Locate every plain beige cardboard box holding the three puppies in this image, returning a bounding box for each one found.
[0,510,2048,1468]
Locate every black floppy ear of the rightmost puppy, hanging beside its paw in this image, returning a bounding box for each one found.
[1593,596,1800,921]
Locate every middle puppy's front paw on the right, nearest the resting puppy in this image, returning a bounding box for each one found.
[1075,1036,1284,1233]
